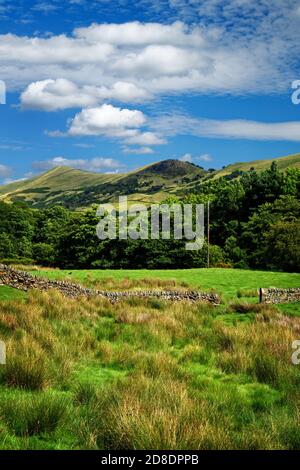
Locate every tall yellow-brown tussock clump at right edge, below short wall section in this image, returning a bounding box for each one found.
[217,307,300,393]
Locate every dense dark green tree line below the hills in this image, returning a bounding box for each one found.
[0,162,300,272]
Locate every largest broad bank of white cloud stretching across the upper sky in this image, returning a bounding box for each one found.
[0,14,300,101]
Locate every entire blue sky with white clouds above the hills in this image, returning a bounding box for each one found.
[0,0,300,183]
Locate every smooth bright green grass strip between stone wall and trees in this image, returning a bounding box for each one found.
[34,268,300,299]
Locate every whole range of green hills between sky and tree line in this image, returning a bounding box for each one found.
[0,154,300,209]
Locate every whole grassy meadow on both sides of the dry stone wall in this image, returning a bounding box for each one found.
[0,269,300,450]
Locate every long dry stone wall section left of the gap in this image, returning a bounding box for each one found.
[0,264,220,305]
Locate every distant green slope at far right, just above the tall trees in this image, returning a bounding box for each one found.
[214,153,300,178]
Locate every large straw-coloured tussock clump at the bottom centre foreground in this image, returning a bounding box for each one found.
[78,375,219,449]
